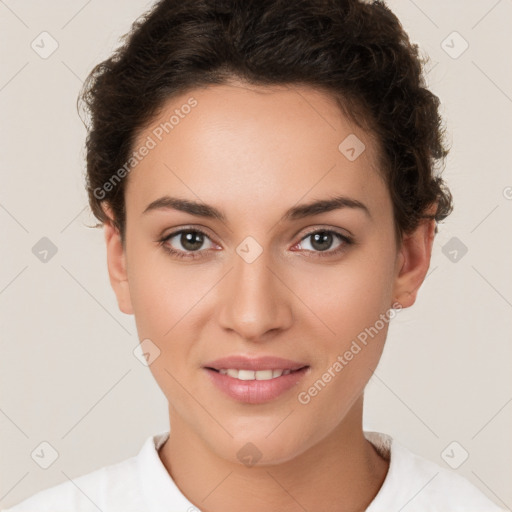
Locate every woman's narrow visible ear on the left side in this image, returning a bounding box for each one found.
[102,205,133,315]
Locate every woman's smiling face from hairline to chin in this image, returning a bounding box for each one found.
[105,85,424,463]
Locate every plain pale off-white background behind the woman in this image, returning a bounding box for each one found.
[0,0,512,508]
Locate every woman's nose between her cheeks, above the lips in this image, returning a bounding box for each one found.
[219,246,293,342]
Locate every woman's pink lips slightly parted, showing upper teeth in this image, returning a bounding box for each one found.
[204,356,309,404]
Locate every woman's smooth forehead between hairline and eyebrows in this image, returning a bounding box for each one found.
[126,83,387,220]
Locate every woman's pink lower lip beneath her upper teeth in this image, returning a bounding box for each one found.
[206,367,309,404]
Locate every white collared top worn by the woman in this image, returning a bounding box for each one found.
[3,431,505,512]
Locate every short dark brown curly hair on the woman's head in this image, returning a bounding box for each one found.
[77,0,453,243]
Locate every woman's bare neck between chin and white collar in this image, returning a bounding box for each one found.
[159,396,389,512]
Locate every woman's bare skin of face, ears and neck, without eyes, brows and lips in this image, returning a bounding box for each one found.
[104,83,434,512]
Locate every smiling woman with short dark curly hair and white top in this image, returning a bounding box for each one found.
[4,0,506,512]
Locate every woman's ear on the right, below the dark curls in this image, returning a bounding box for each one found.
[393,204,437,308]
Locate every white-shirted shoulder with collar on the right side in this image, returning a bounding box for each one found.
[365,432,504,512]
